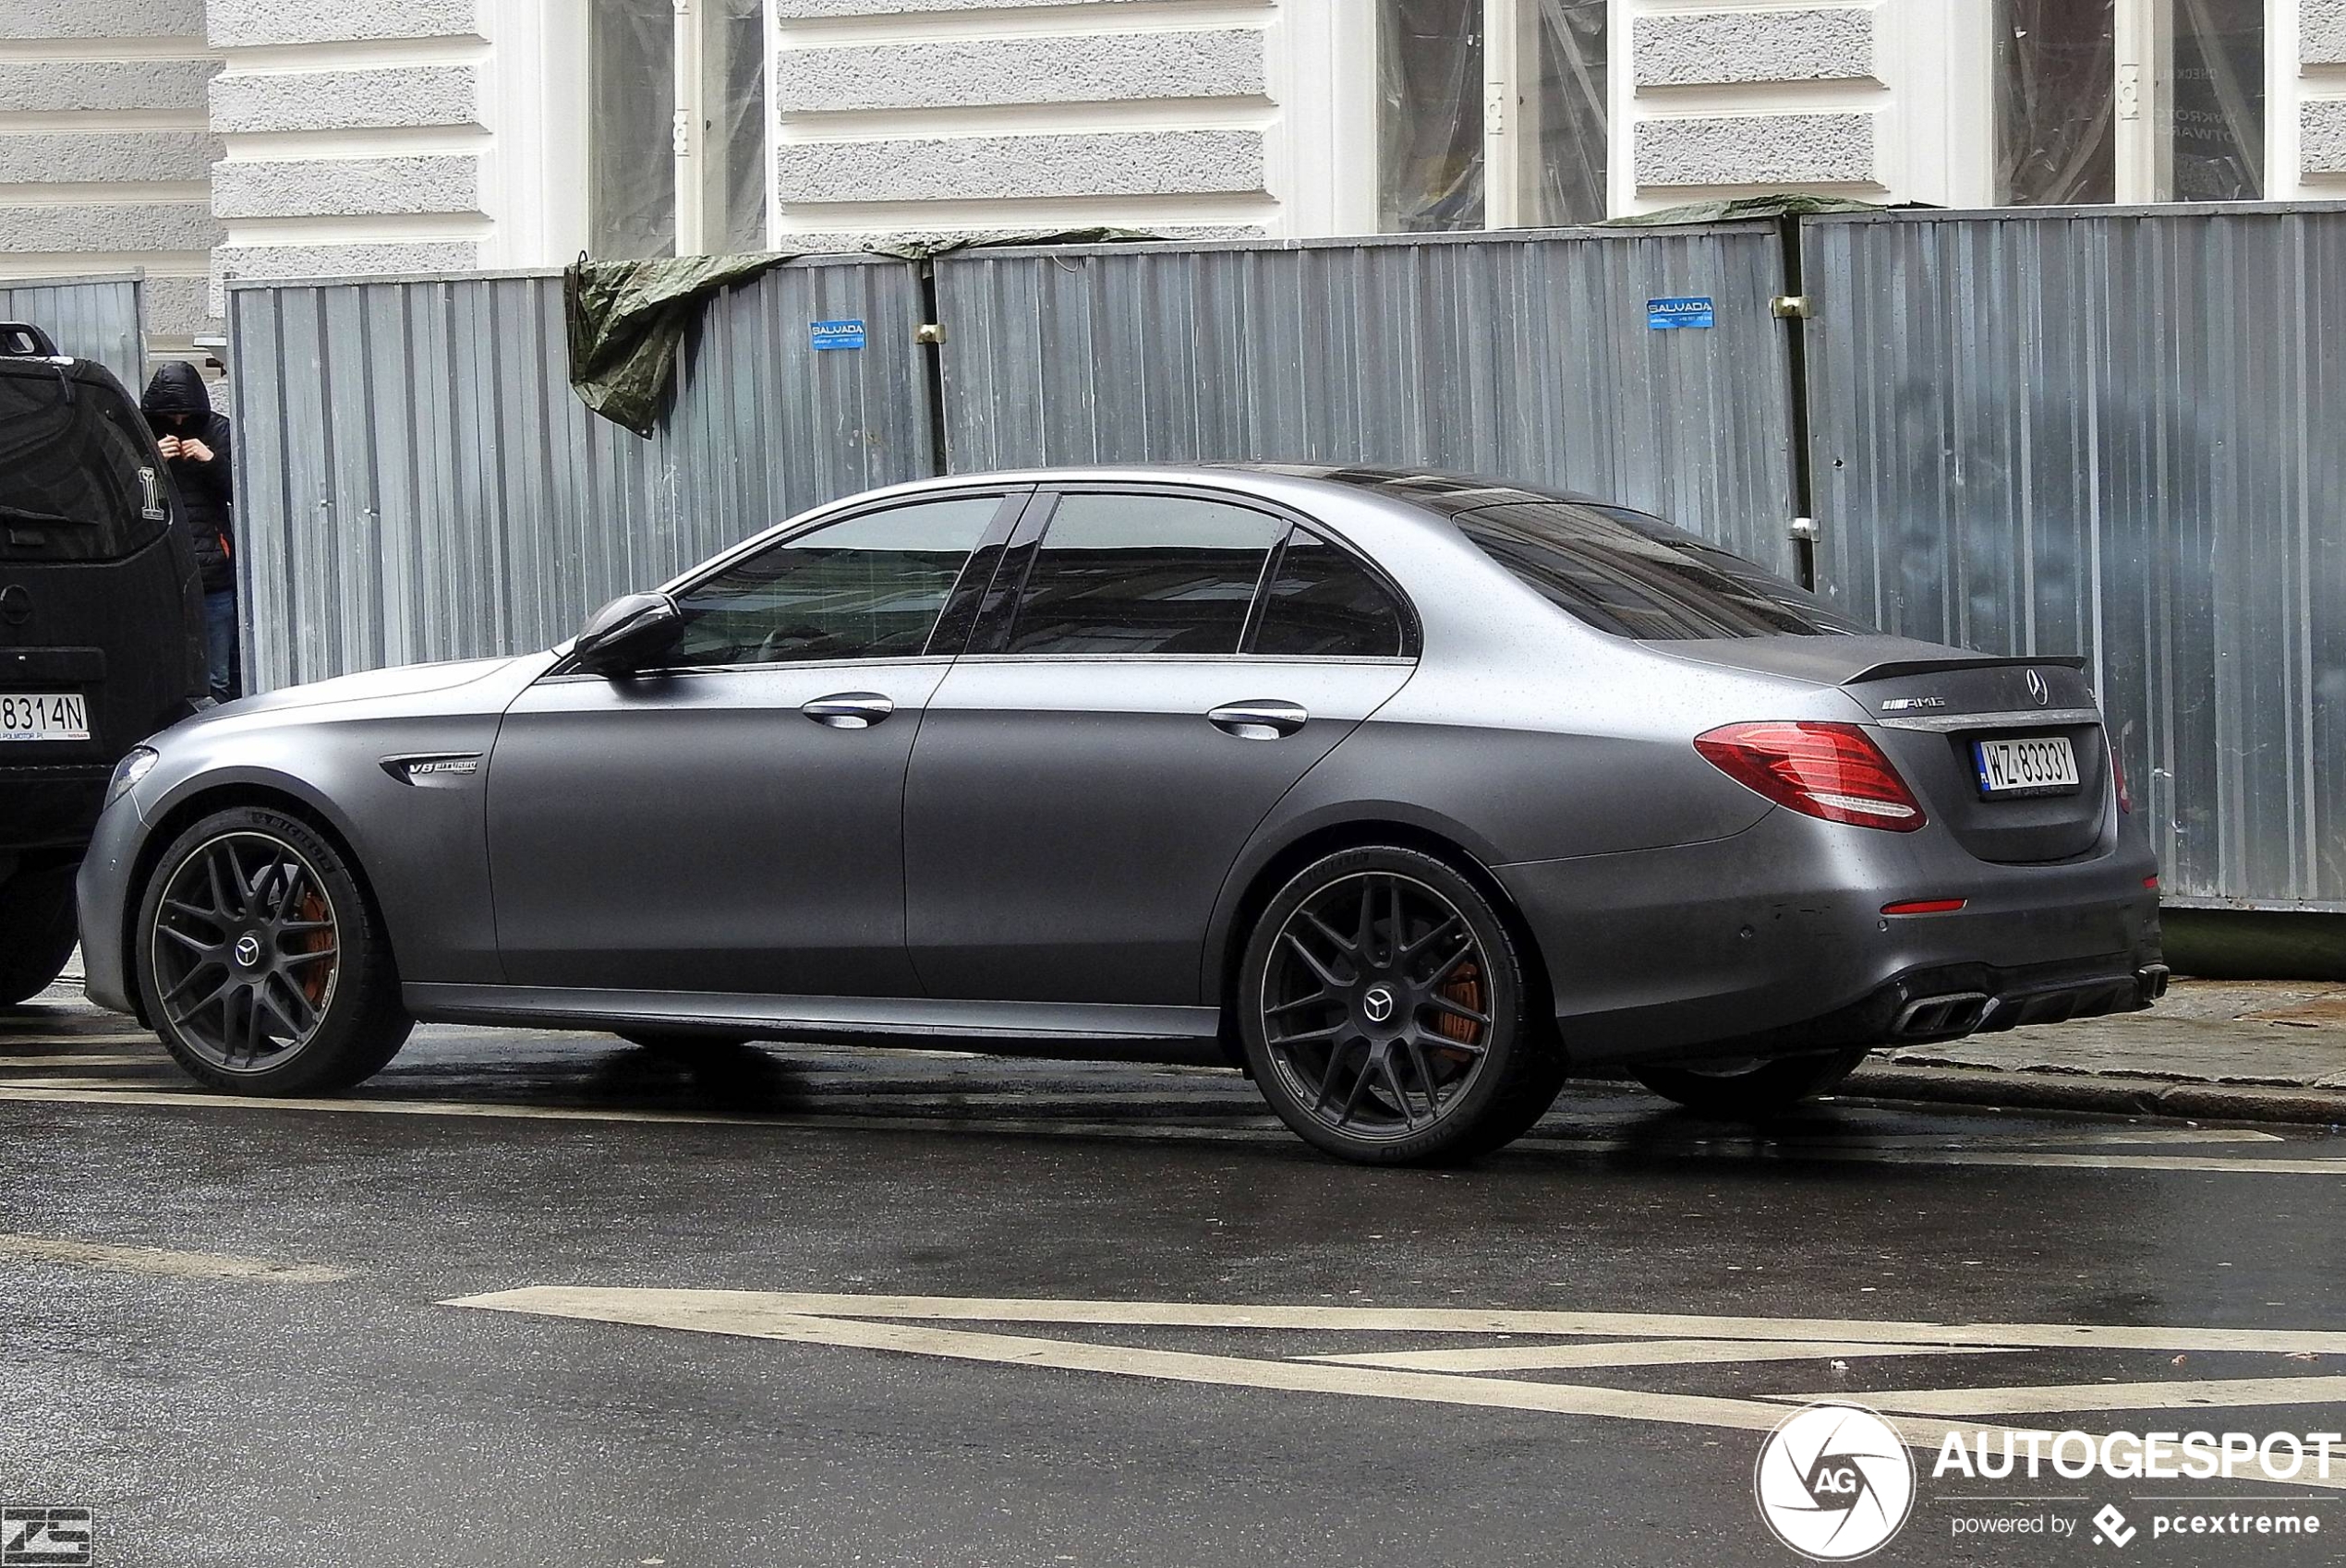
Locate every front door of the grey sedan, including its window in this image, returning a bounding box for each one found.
[488,492,1022,996]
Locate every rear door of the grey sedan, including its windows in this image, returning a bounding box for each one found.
[905,485,1415,1006]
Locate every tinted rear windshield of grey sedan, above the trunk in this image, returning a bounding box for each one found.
[1457,501,1872,640]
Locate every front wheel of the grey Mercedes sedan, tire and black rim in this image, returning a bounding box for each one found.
[134,806,416,1094]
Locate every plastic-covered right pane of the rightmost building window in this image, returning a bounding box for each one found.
[2156,0,2264,201]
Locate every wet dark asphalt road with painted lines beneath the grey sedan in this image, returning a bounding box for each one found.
[0,996,2346,1568]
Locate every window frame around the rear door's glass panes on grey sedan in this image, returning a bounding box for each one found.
[961,478,1424,663]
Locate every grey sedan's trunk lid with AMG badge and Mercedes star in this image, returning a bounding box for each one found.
[1647,635,2116,865]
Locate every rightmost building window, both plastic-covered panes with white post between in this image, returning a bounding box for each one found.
[1994,0,2267,206]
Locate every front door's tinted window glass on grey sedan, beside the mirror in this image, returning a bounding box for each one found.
[669,495,1002,663]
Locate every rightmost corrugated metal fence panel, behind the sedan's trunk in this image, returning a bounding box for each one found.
[1802,206,2346,910]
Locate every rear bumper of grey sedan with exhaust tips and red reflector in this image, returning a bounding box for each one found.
[1494,811,2165,1064]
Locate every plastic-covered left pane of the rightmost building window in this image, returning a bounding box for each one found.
[1997,0,2119,206]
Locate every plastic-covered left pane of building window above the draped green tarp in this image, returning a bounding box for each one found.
[586,0,676,260]
